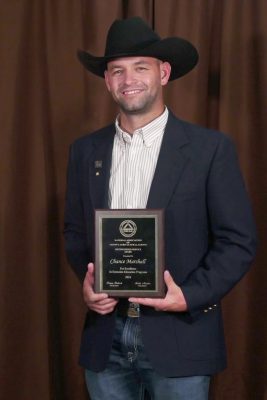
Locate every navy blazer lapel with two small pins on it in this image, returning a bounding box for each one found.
[89,125,115,208]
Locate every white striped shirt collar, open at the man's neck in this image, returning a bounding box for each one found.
[115,107,169,147]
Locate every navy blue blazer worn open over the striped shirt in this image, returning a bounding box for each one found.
[64,113,256,377]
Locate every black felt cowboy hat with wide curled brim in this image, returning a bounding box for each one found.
[78,17,198,80]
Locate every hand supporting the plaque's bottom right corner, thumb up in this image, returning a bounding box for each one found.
[129,271,187,312]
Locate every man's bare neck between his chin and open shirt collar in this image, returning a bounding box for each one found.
[120,105,165,135]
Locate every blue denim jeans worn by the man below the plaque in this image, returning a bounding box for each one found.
[85,317,210,400]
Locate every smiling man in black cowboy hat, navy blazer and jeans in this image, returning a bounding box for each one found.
[65,17,256,400]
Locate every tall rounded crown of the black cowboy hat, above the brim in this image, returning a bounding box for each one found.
[105,17,160,57]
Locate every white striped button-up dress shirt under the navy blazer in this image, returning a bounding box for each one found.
[109,108,169,209]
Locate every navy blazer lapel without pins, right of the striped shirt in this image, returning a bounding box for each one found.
[147,113,189,208]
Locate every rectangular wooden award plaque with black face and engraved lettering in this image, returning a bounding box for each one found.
[95,209,164,297]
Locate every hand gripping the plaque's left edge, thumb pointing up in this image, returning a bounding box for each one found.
[83,263,118,315]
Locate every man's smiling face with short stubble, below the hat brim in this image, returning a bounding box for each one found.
[105,57,171,114]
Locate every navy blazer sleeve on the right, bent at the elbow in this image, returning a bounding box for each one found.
[181,136,257,315]
